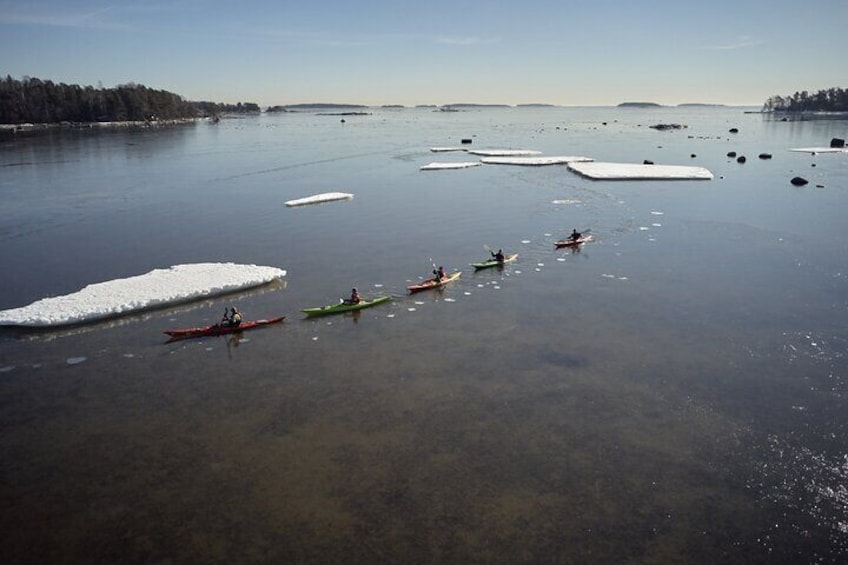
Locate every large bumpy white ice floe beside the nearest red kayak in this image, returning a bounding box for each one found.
[0,263,286,328]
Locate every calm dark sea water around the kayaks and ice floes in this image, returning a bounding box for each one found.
[0,107,848,563]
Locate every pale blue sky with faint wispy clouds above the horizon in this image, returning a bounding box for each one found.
[0,0,848,107]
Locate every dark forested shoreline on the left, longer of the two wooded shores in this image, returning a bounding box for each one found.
[0,75,260,124]
